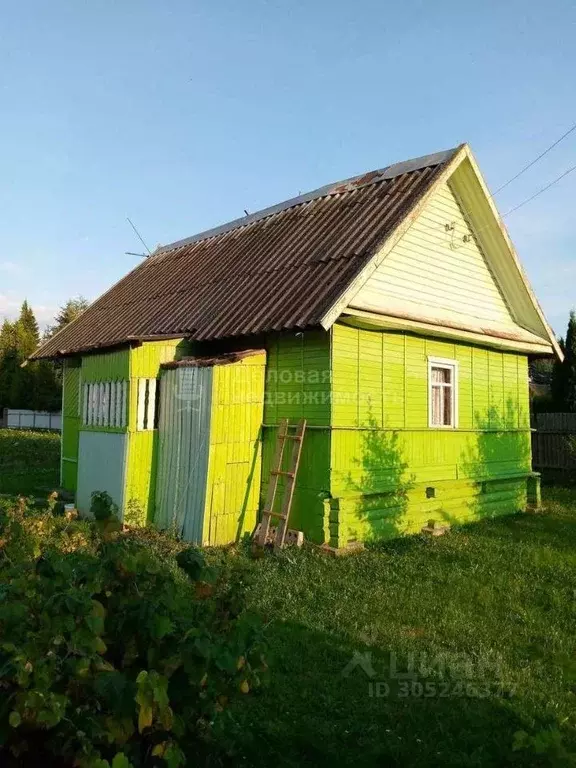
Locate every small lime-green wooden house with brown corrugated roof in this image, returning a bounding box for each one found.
[34,145,561,549]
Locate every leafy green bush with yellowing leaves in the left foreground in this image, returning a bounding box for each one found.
[0,502,265,768]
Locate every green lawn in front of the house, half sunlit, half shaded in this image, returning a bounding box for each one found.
[220,489,576,766]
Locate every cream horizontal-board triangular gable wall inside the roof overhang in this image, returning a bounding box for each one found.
[350,183,518,331]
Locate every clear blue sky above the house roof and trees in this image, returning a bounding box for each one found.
[0,0,576,332]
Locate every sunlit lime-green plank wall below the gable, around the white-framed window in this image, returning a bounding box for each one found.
[330,323,531,547]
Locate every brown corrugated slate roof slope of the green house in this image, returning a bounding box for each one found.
[34,149,458,359]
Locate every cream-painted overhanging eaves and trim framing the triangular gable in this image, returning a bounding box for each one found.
[321,144,563,360]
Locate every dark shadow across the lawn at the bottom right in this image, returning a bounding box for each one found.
[226,621,548,767]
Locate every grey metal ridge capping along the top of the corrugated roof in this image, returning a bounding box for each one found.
[152,144,463,257]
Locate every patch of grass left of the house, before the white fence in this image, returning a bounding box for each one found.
[0,429,60,496]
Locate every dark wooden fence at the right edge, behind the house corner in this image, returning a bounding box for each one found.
[532,413,576,470]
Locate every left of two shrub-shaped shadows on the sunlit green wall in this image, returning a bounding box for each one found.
[339,413,415,546]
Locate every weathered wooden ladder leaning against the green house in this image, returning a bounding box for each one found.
[256,419,306,549]
